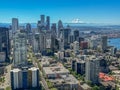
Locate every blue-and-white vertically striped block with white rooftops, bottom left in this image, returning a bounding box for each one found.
[10,67,39,90]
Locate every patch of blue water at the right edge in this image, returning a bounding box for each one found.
[108,38,120,50]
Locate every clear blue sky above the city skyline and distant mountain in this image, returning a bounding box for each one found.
[0,0,120,24]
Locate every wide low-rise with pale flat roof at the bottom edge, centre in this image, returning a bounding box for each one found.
[50,75,79,90]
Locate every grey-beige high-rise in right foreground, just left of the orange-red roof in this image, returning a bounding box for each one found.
[85,56,100,84]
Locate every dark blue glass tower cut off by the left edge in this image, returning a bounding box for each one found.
[0,27,10,61]
